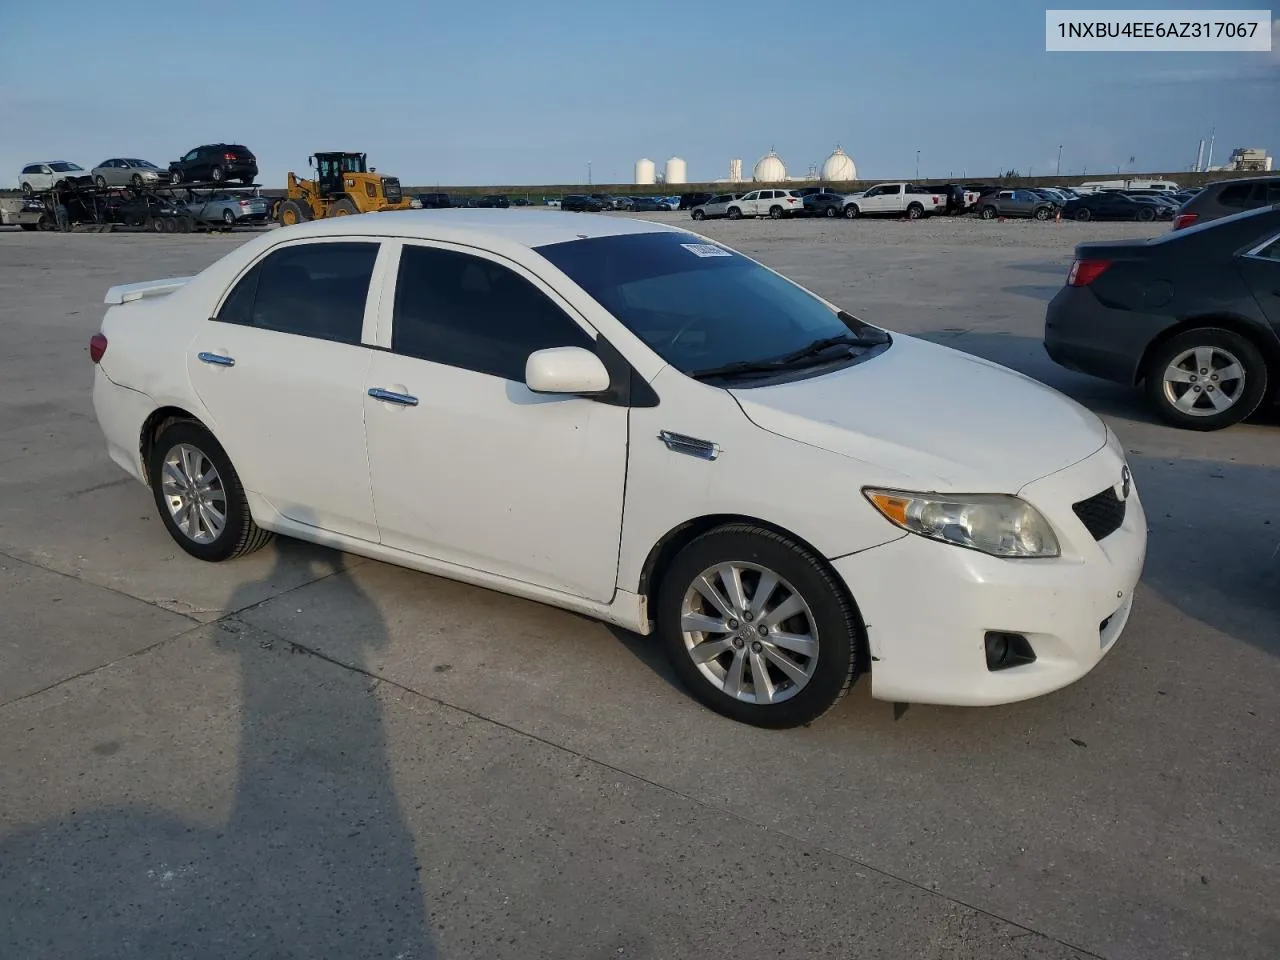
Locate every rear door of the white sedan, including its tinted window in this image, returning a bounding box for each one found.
[187,238,380,543]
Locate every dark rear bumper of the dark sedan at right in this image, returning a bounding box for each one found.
[1044,285,1174,385]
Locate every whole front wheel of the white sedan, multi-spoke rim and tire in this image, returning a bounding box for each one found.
[655,524,863,728]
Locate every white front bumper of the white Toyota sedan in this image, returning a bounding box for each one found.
[835,439,1147,707]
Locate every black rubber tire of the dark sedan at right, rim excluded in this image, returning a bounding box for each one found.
[1143,326,1268,430]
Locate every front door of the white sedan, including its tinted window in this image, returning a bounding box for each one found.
[365,241,628,603]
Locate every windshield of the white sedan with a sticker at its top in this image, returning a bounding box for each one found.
[538,232,885,374]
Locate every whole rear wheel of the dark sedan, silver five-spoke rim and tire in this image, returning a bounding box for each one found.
[1146,335,1267,430]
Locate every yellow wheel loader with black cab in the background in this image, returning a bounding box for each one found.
[279,152,410,227]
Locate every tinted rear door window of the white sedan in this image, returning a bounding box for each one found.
[215,242,378,344]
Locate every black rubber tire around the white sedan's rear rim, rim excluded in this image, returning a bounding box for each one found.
[147,420,273,563]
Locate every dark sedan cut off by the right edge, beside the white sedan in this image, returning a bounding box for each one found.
[1044,204,1280,430]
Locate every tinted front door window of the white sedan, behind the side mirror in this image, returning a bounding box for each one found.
[392,244,595,383]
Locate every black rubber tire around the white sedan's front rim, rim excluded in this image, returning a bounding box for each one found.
[657,524,865,730]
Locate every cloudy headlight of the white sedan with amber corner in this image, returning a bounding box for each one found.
[863,488,1060,557]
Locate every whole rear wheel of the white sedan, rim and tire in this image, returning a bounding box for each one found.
[147,420,271,563]
